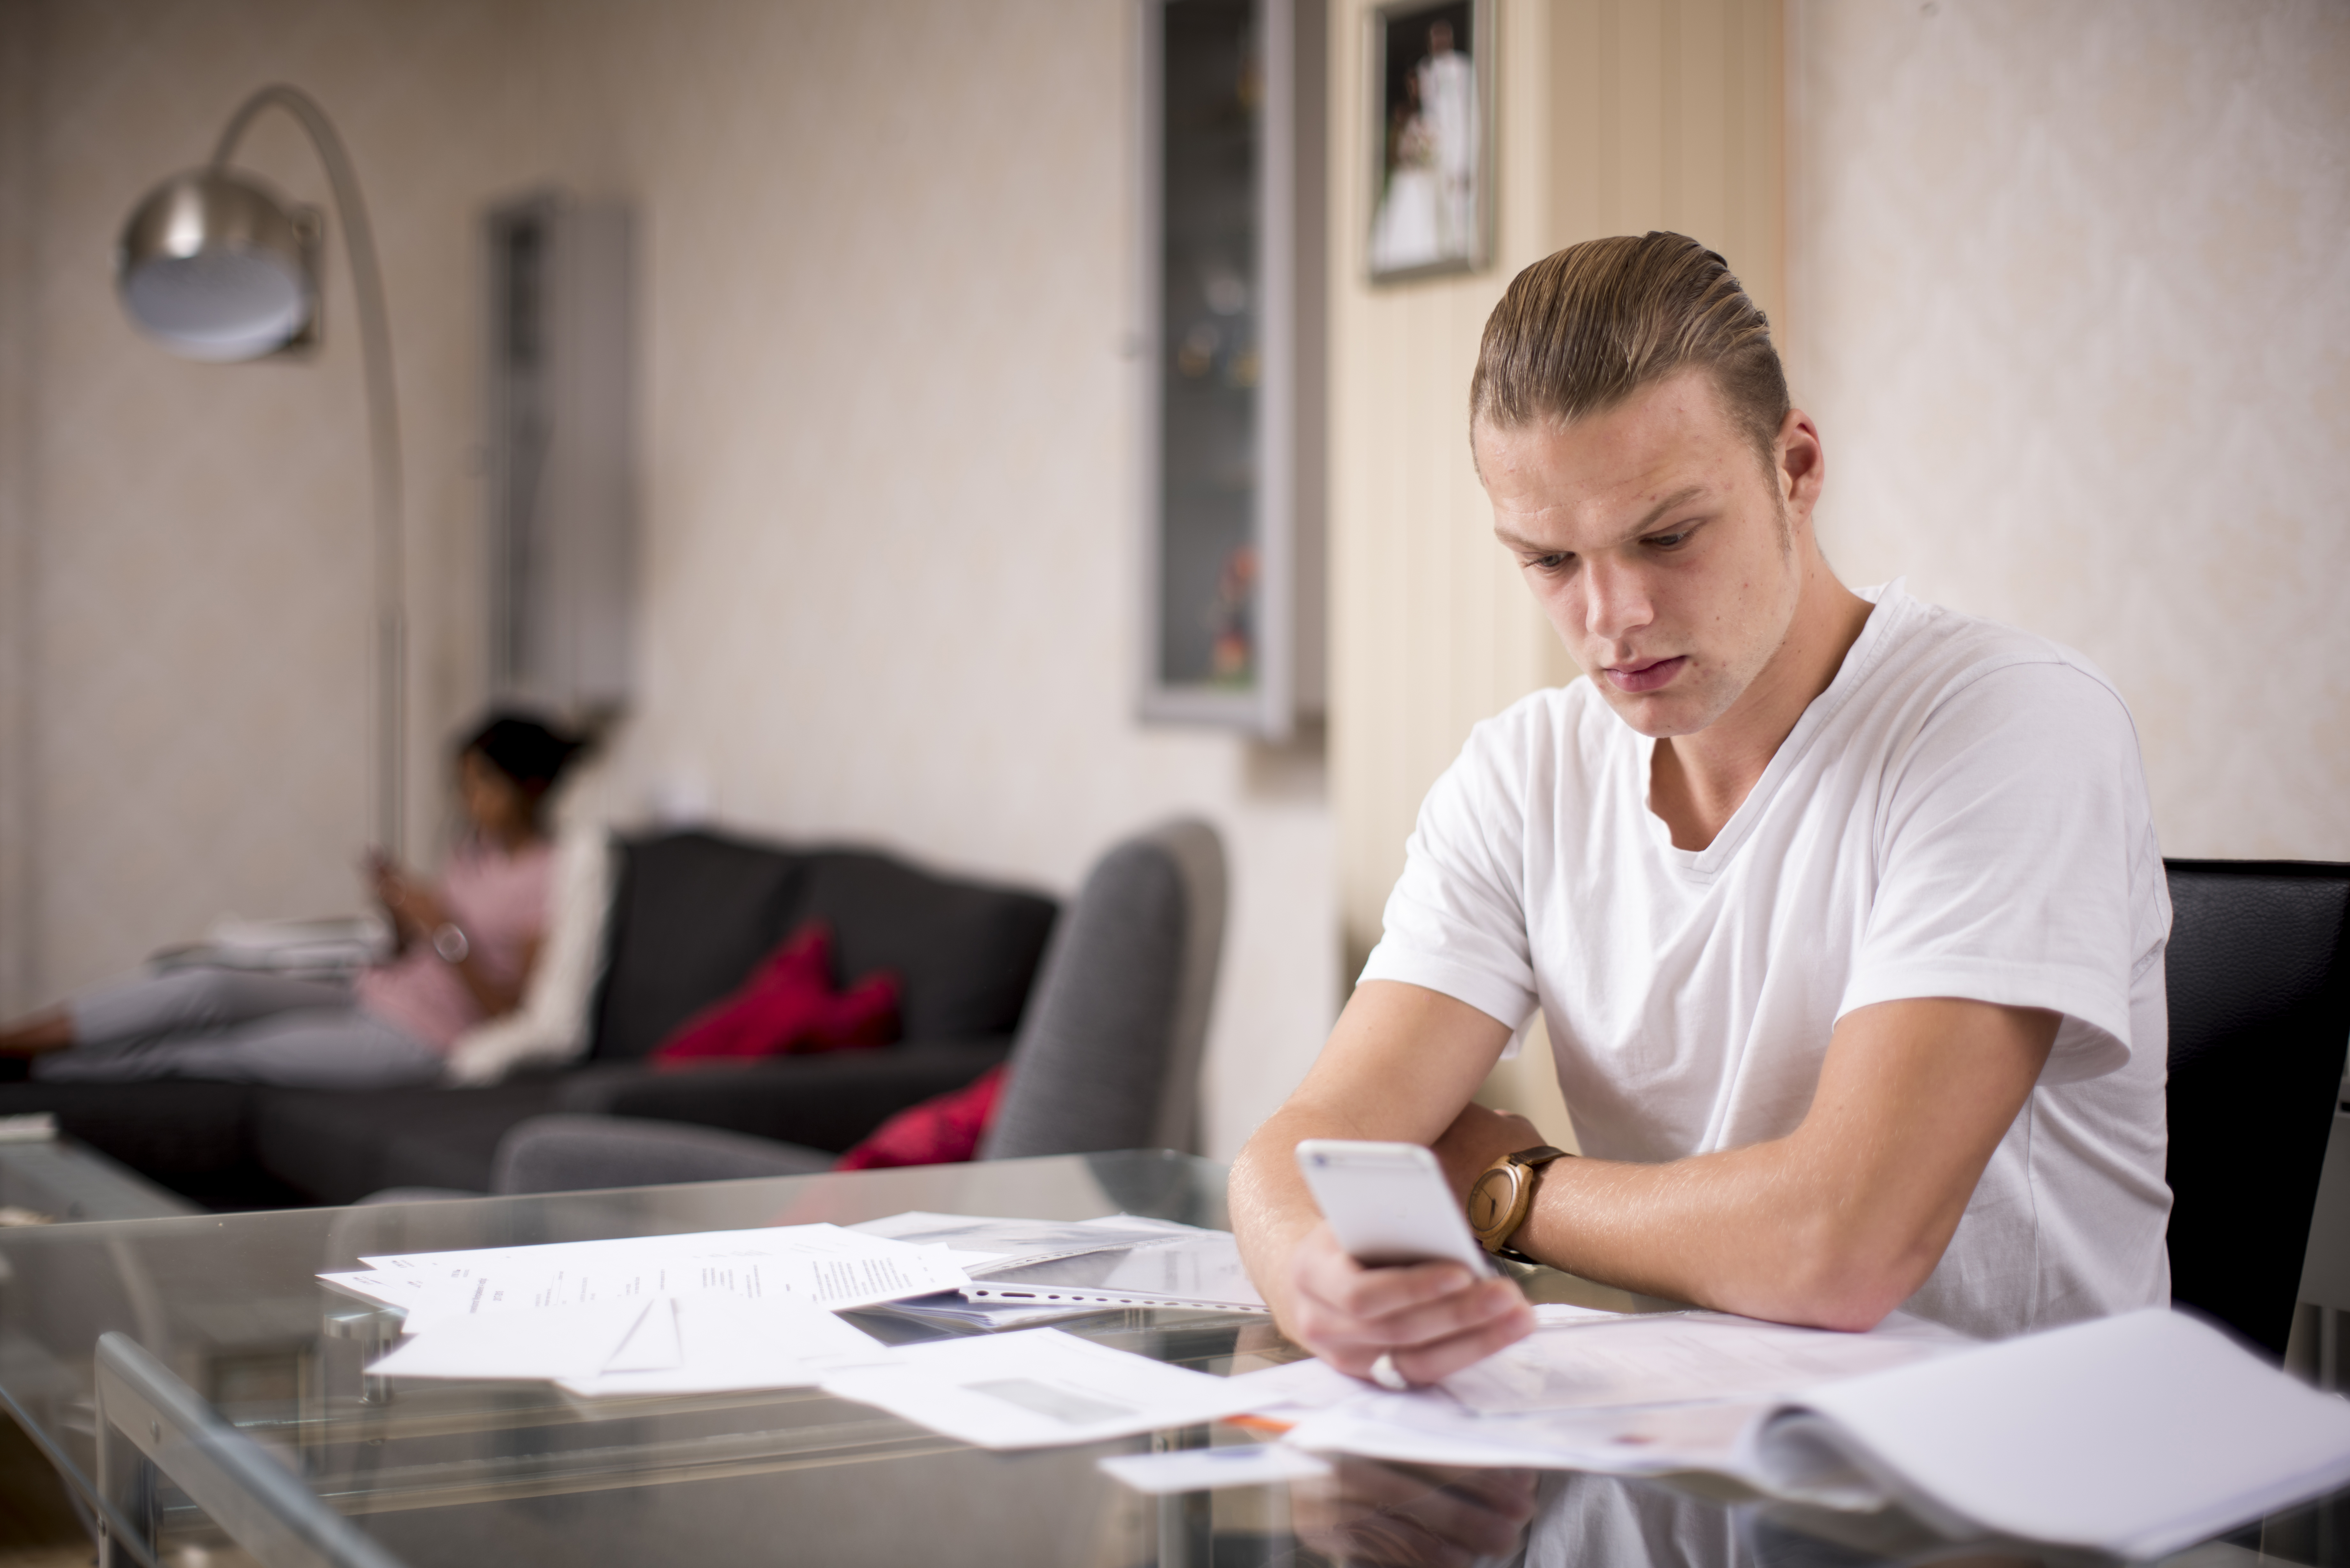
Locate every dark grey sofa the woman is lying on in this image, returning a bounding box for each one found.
[0,832,1058,1208]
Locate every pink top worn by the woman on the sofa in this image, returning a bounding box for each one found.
[360,844,555,1051]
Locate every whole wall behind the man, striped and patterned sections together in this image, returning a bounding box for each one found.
[1332,0,2350,1133]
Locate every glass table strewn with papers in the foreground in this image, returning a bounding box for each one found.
[0,1152,2345,1568]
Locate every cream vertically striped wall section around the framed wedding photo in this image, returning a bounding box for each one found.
[1330,0,1784,1142]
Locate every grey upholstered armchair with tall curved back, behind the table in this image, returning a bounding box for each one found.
[494,818,1224,1194]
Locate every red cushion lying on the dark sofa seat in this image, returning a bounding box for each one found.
[653,919,898,1067]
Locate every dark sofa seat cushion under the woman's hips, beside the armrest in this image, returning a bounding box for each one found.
[254,1077,557,1204]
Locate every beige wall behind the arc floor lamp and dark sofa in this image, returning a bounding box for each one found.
[0,0,1337,1152]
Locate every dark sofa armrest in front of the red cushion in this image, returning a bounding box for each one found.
[555,1037,1013,1152]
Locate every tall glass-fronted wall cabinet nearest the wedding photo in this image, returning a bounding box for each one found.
[1137,0,1328,741]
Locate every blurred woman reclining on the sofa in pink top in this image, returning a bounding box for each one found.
[0,715,580,1089]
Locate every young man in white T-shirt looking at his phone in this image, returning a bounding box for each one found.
[1232,233,2169,1387]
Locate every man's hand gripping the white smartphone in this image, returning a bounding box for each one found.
[1283,1225,1535,1385]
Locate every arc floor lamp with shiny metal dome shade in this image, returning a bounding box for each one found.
[115,85,406,856]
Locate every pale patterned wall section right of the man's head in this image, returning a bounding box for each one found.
[1791,0,2350,860]
